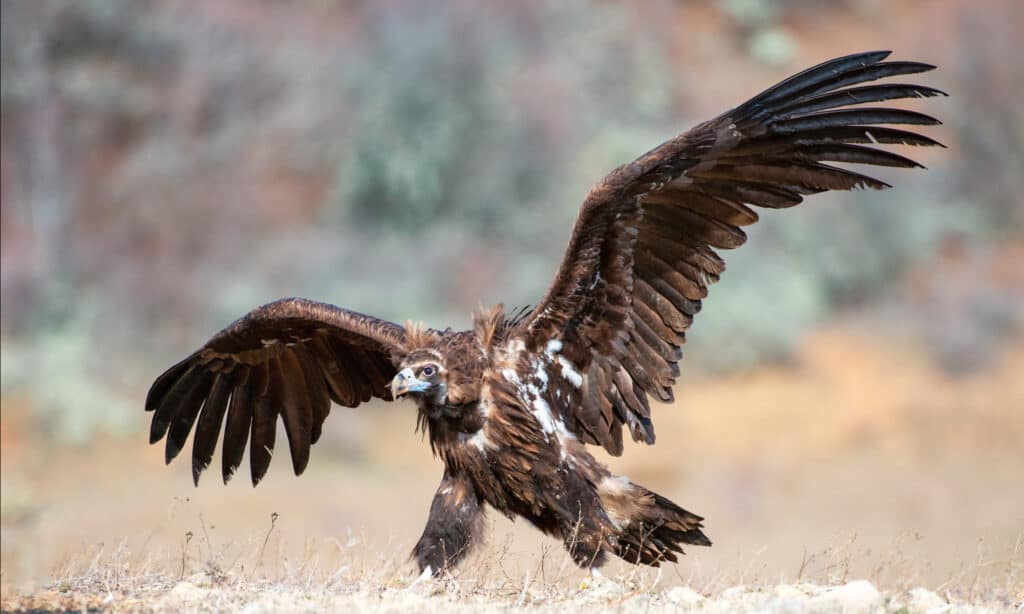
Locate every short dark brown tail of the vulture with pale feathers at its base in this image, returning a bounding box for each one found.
[599,477,711,567]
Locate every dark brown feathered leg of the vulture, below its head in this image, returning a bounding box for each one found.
[413,471,483,575]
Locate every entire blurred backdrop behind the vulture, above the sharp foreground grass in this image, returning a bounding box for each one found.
[0,0,1024,586]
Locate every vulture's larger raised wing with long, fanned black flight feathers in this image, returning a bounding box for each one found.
[514,51,945,454]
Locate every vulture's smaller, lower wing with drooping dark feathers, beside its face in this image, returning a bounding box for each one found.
[145,299,406,486]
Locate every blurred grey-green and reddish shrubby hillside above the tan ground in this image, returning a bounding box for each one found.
[0,0,1024,439]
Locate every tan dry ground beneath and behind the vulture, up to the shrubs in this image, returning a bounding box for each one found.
[0,325,1024,611]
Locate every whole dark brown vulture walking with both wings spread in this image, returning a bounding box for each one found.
[145,51,946,576]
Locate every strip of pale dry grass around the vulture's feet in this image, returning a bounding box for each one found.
[2,517,1024,612]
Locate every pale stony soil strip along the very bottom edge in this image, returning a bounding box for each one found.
[5,579,1020,612]
